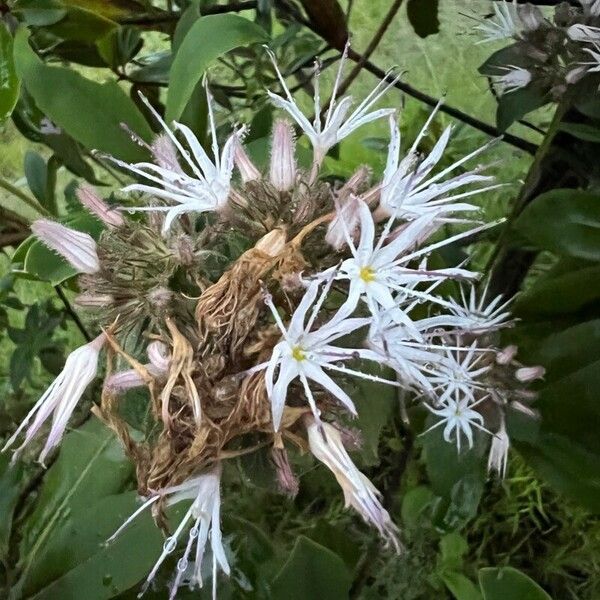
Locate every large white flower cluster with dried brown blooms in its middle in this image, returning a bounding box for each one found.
[6,45,543,597]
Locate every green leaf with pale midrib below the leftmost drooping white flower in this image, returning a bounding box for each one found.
[14,418,132,597]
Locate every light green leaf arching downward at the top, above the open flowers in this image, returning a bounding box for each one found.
[166,14,267,122]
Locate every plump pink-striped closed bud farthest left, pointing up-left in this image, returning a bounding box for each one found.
[31,219,100,275]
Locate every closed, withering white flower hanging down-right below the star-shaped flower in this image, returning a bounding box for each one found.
[306,417,400,552]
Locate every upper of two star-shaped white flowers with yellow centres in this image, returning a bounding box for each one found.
[332,202,475,324]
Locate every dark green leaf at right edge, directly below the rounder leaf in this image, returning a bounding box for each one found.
[514,266,600,317]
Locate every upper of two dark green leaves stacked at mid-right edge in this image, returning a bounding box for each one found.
[512,189,600,261]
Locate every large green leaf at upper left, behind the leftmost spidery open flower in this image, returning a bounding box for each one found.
[15,29,152,161]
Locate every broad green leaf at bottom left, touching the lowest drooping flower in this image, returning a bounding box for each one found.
[25,491,169,600]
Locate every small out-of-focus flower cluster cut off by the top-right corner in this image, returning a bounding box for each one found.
[475,0,600,97]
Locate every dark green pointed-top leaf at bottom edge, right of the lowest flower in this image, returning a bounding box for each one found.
[272,536,352,600]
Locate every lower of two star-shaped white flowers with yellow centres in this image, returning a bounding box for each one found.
[265,278,395,431]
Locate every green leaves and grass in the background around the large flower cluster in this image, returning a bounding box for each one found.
[0,0,600,600]
